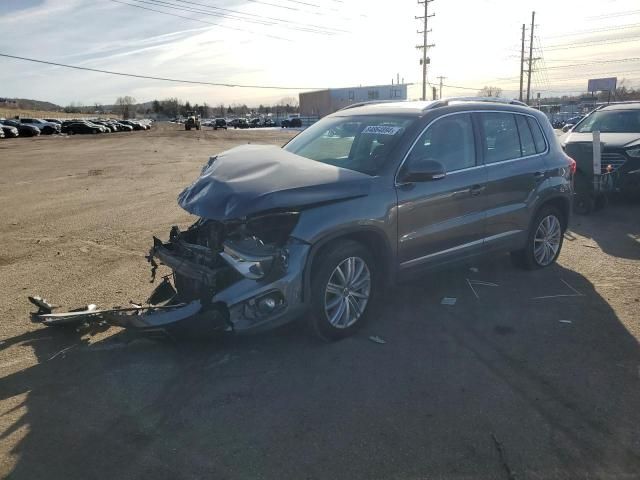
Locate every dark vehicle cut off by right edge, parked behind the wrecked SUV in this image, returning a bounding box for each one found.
[561,102,640,201]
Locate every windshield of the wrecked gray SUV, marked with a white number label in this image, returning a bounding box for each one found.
[284,115,414,175]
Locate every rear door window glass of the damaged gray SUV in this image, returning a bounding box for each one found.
[480,112,521,163]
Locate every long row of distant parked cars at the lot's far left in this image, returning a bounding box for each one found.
[0,118,153,138]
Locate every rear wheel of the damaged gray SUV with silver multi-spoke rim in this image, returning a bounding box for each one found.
[511,205,566,270]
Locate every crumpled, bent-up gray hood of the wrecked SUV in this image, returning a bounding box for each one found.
[178,145,372,221]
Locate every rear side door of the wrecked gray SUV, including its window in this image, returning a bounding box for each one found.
[477,111,547,248]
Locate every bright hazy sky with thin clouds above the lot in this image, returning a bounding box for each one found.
[0,0,640,105]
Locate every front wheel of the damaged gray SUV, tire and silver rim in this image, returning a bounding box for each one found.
[309,240,379,341]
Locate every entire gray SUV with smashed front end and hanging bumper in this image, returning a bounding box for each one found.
[30,99,575,339]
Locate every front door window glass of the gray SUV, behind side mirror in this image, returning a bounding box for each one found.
[407,113,476,172]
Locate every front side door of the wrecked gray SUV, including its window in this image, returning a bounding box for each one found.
[396,112,487,271]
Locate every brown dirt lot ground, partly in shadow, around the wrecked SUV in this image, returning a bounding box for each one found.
[0,125,640,480]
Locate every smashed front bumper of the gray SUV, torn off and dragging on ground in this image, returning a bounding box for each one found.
[29,226,310,333]
